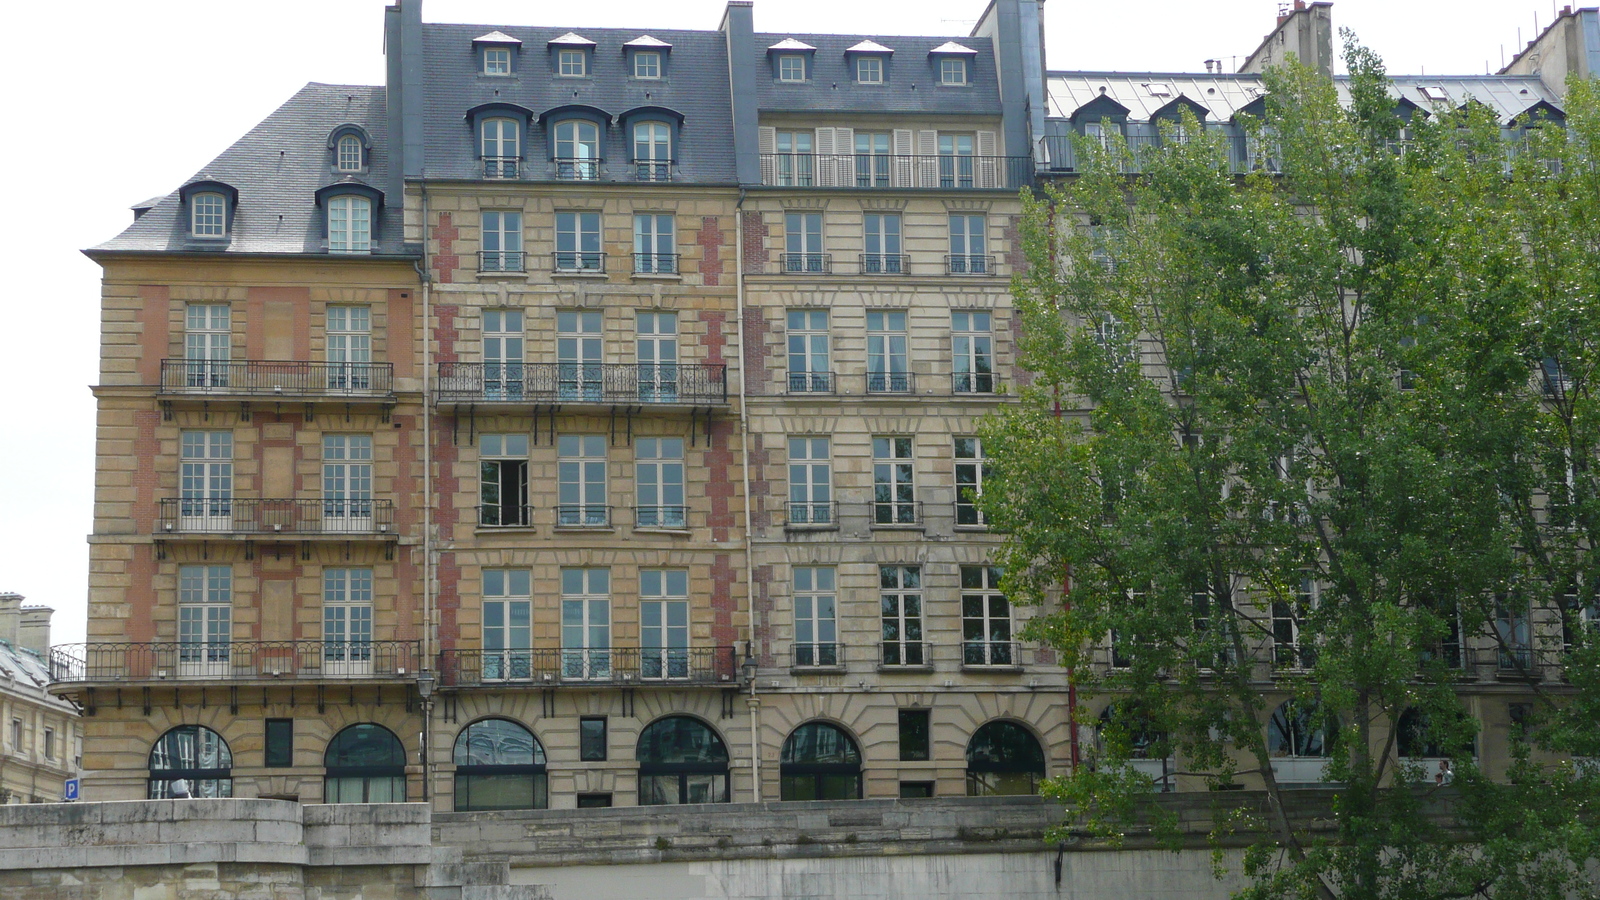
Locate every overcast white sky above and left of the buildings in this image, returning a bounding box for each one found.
[0,0,1554,644]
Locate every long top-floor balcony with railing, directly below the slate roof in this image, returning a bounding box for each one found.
[762,154,1034,191]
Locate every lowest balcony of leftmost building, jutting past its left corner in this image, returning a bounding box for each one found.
[50,641,421,685]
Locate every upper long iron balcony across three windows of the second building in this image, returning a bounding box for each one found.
[434,362,728,408]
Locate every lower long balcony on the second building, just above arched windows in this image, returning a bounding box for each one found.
[438,647,738,689]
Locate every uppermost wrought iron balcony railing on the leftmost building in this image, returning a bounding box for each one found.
[158,359,394,400]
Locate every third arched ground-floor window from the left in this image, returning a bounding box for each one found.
[453,719,550,812]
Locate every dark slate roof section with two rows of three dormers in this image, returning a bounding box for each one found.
[422,22,738,184]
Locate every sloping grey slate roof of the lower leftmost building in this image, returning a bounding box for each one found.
[93,83,405,258]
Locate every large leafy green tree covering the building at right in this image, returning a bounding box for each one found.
[982,35,1600,898]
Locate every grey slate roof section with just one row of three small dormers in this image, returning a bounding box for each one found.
[755,32,1000,119]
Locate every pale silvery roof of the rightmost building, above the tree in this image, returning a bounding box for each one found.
[1045,72,1562,125]
